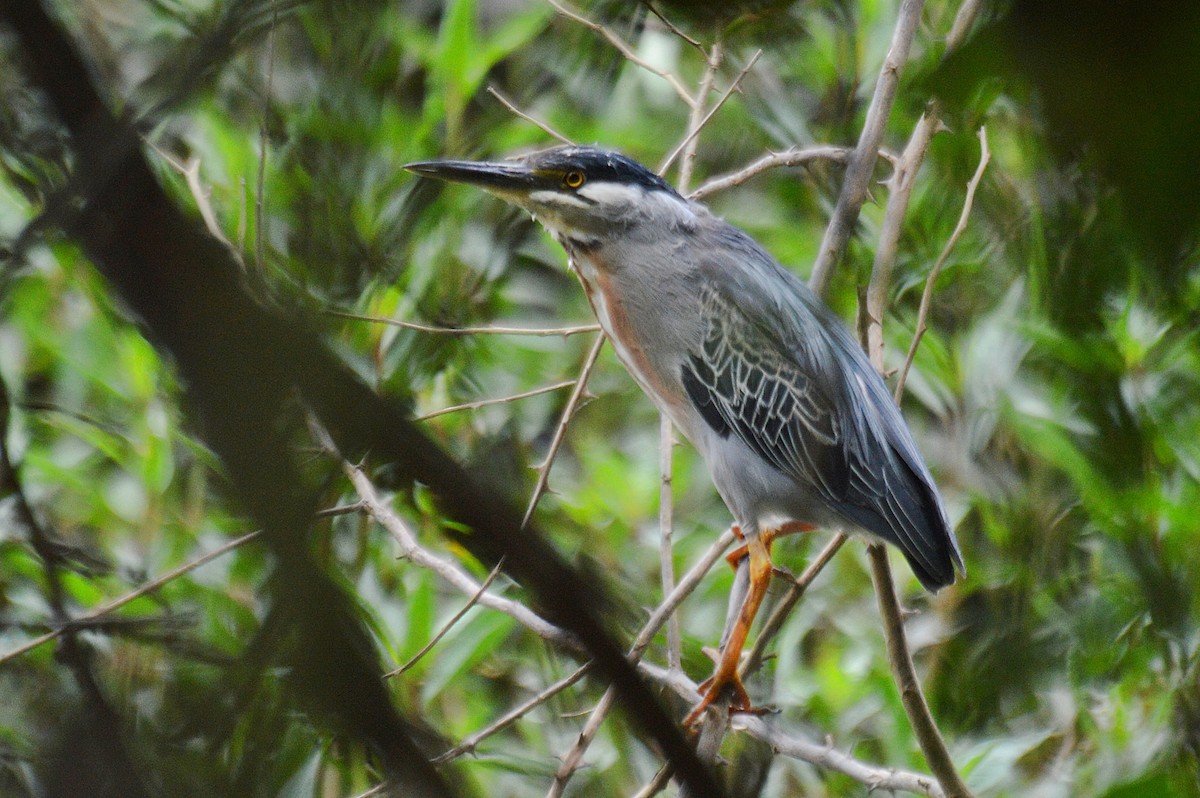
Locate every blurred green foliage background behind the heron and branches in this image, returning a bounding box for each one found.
[0,0,1200,798]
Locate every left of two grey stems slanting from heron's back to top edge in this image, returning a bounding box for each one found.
[809,0,925,296]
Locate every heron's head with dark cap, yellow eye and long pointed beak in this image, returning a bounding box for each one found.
[404,146,692,245]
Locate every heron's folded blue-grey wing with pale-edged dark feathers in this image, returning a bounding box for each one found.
[680,252,962,589]
